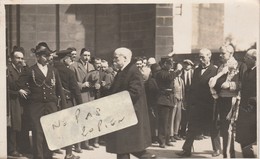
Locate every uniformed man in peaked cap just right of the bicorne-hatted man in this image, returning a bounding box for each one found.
[54,50,82,159]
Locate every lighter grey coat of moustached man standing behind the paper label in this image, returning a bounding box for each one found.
[70,60,95,103]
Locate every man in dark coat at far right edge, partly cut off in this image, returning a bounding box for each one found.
[236,49,257,158]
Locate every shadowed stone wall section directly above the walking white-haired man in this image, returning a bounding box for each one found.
[120,4,155,57]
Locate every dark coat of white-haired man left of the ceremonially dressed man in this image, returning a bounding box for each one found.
[190,64,217,126]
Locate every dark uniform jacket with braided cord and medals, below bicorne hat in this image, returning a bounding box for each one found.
[17,64,67,109]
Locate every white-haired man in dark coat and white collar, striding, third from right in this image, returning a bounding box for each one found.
[177,49,221,157]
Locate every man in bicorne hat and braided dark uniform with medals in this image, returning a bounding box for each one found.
[17,42,66,159]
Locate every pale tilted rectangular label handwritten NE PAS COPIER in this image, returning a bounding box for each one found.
[41,91,138,150]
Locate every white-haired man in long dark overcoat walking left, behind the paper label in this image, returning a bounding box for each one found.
[106,48,155,159]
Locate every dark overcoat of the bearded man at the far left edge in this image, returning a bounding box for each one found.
[7,64,22,131]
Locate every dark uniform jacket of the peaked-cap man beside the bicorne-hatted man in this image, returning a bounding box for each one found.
[54,62,82,105]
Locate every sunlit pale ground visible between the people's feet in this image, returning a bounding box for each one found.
[8,138,257,159]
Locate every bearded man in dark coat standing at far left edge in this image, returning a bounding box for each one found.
[7,46,25,157]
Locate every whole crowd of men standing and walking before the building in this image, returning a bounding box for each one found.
[7,42,257,159]
